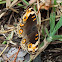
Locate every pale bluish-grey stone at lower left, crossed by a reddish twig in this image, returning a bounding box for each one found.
[6,47,27,62]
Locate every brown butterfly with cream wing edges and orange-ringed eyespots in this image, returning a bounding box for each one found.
[18,7,39,53]
